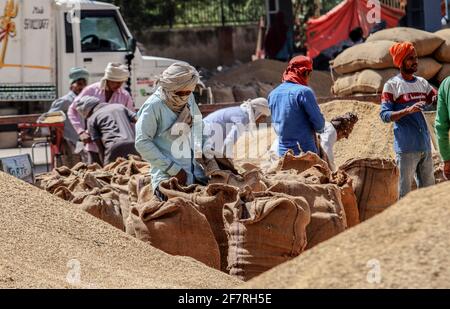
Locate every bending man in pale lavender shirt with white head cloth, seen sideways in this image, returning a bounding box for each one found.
[203,98,270,157]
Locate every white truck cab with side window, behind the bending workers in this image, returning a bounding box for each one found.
[55,0,180,108]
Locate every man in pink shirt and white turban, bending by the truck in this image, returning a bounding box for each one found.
[68,63,135,163]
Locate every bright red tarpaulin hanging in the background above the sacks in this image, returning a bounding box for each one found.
[306,0,405,58]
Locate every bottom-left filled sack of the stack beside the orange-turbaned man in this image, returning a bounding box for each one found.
[332,69,399,96]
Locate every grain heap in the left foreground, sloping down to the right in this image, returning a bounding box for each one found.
[0,172,243,288]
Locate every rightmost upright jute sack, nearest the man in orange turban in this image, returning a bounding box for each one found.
[340,159,399,221]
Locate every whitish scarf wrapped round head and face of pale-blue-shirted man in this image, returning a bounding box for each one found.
[156,62,200,114]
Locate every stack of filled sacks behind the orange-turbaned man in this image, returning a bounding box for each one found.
[331,27,450,96]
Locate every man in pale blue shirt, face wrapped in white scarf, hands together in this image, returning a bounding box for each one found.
[136,63,207,199]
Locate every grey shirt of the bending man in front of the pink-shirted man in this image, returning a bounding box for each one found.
[87,103,136,158]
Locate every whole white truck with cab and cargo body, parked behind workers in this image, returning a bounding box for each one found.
[0,0,182,115]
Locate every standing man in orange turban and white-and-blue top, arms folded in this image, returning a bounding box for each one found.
[380,42,436,198]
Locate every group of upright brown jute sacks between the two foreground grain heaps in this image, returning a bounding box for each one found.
[39,153,398,280]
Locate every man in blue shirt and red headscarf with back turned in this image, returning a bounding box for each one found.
[269,56,325,156]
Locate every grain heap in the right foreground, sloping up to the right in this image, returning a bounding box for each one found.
[242,183,450,289]
